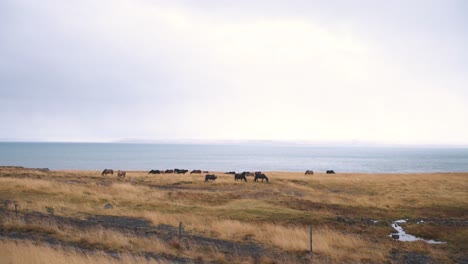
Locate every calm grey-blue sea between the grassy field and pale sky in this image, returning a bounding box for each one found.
[0,142,468,173]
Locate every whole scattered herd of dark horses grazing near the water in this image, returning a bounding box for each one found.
[101,169,335,182]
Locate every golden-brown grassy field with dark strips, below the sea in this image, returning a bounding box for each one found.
[0,167,468,263]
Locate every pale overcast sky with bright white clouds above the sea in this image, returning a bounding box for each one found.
[0,0,468,145]
